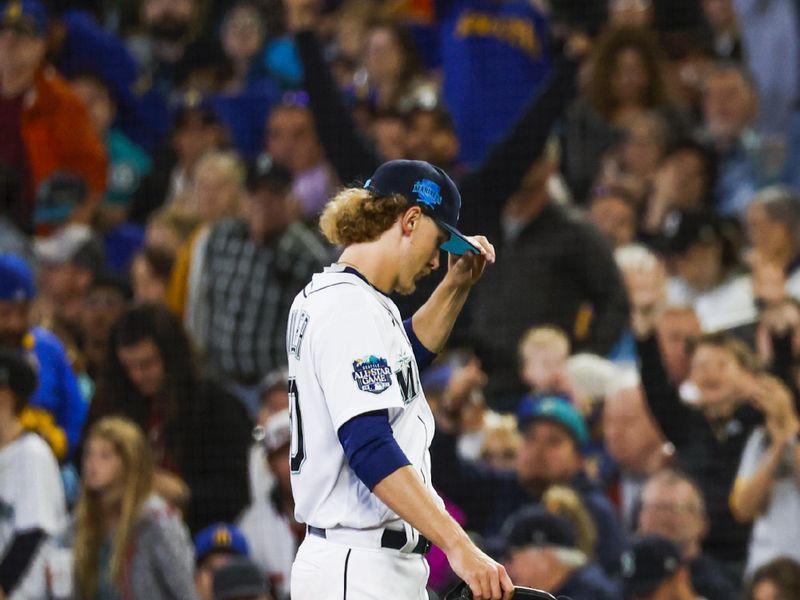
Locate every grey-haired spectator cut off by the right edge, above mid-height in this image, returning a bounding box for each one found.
[746,187,800,299]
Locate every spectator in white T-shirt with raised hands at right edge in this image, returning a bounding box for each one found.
[730,377,800,576]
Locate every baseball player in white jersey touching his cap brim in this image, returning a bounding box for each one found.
[287,160,513,600]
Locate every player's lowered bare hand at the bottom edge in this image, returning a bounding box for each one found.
[447,536,514,600]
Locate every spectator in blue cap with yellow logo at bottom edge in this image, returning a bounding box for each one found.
[194,523,250,600]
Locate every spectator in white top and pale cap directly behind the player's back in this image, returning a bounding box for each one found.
[239,409,305,598]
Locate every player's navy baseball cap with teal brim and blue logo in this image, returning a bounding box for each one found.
[364,160,481,255]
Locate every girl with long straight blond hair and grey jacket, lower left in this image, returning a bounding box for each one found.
[74,417,194,600]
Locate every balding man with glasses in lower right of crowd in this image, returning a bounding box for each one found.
[637,469,738,600]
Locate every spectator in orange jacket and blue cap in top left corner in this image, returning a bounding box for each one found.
[0,0,107,231]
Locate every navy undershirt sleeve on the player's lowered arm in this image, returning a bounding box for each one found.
[339,410,411,491]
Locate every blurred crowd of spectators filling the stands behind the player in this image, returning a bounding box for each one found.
[0,0,800,600]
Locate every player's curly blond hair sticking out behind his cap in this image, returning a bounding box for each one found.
[319,188,408,247]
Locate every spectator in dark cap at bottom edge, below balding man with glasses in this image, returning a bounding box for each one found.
[622,536,702,600]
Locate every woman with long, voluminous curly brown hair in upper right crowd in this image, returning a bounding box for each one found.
[564,26,680,199]
